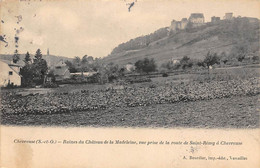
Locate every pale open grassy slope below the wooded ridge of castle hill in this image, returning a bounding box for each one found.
[104,20,259,64]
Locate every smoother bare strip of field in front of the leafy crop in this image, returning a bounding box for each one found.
[2,96,259,128]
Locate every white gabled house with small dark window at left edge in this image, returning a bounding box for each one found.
[0,60,21,87]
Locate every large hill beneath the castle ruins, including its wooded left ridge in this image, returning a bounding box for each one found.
[103,17,260,65]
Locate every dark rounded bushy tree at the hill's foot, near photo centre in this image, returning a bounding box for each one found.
[135,58,157,73]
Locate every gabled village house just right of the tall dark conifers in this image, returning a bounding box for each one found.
[52,60,70,81]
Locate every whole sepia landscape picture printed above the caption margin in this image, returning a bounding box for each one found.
[0,1,260,128]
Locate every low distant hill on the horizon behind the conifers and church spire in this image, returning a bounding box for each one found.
[0,54,72,66]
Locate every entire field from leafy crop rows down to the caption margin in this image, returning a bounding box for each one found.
[1,67,260,128]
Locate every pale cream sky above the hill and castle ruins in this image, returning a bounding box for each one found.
[0,0,260,58]
